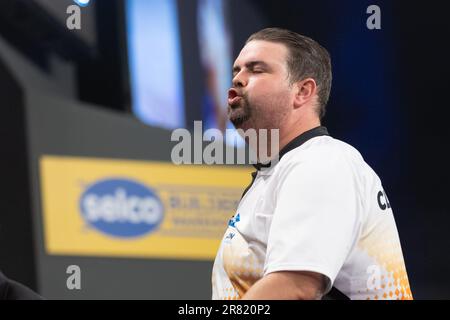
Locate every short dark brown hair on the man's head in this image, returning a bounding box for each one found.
[246,28,332,118]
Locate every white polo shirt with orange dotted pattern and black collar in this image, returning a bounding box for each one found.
[212,127,412,300]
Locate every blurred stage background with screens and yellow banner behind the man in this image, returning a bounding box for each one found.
[0,0,450,299]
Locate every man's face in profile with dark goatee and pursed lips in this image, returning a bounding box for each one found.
[228,40,294,130]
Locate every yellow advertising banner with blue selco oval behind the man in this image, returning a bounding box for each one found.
[40,156,252,260]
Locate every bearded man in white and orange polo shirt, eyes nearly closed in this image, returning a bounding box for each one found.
[212,28,412,300]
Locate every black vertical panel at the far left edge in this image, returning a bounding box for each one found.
[0,60,36,288]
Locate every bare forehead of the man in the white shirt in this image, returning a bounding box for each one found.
[234,40,287,66]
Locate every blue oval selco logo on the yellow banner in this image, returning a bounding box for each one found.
[80,179,164,237]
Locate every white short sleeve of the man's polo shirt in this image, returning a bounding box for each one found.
[264,152,360,293]
